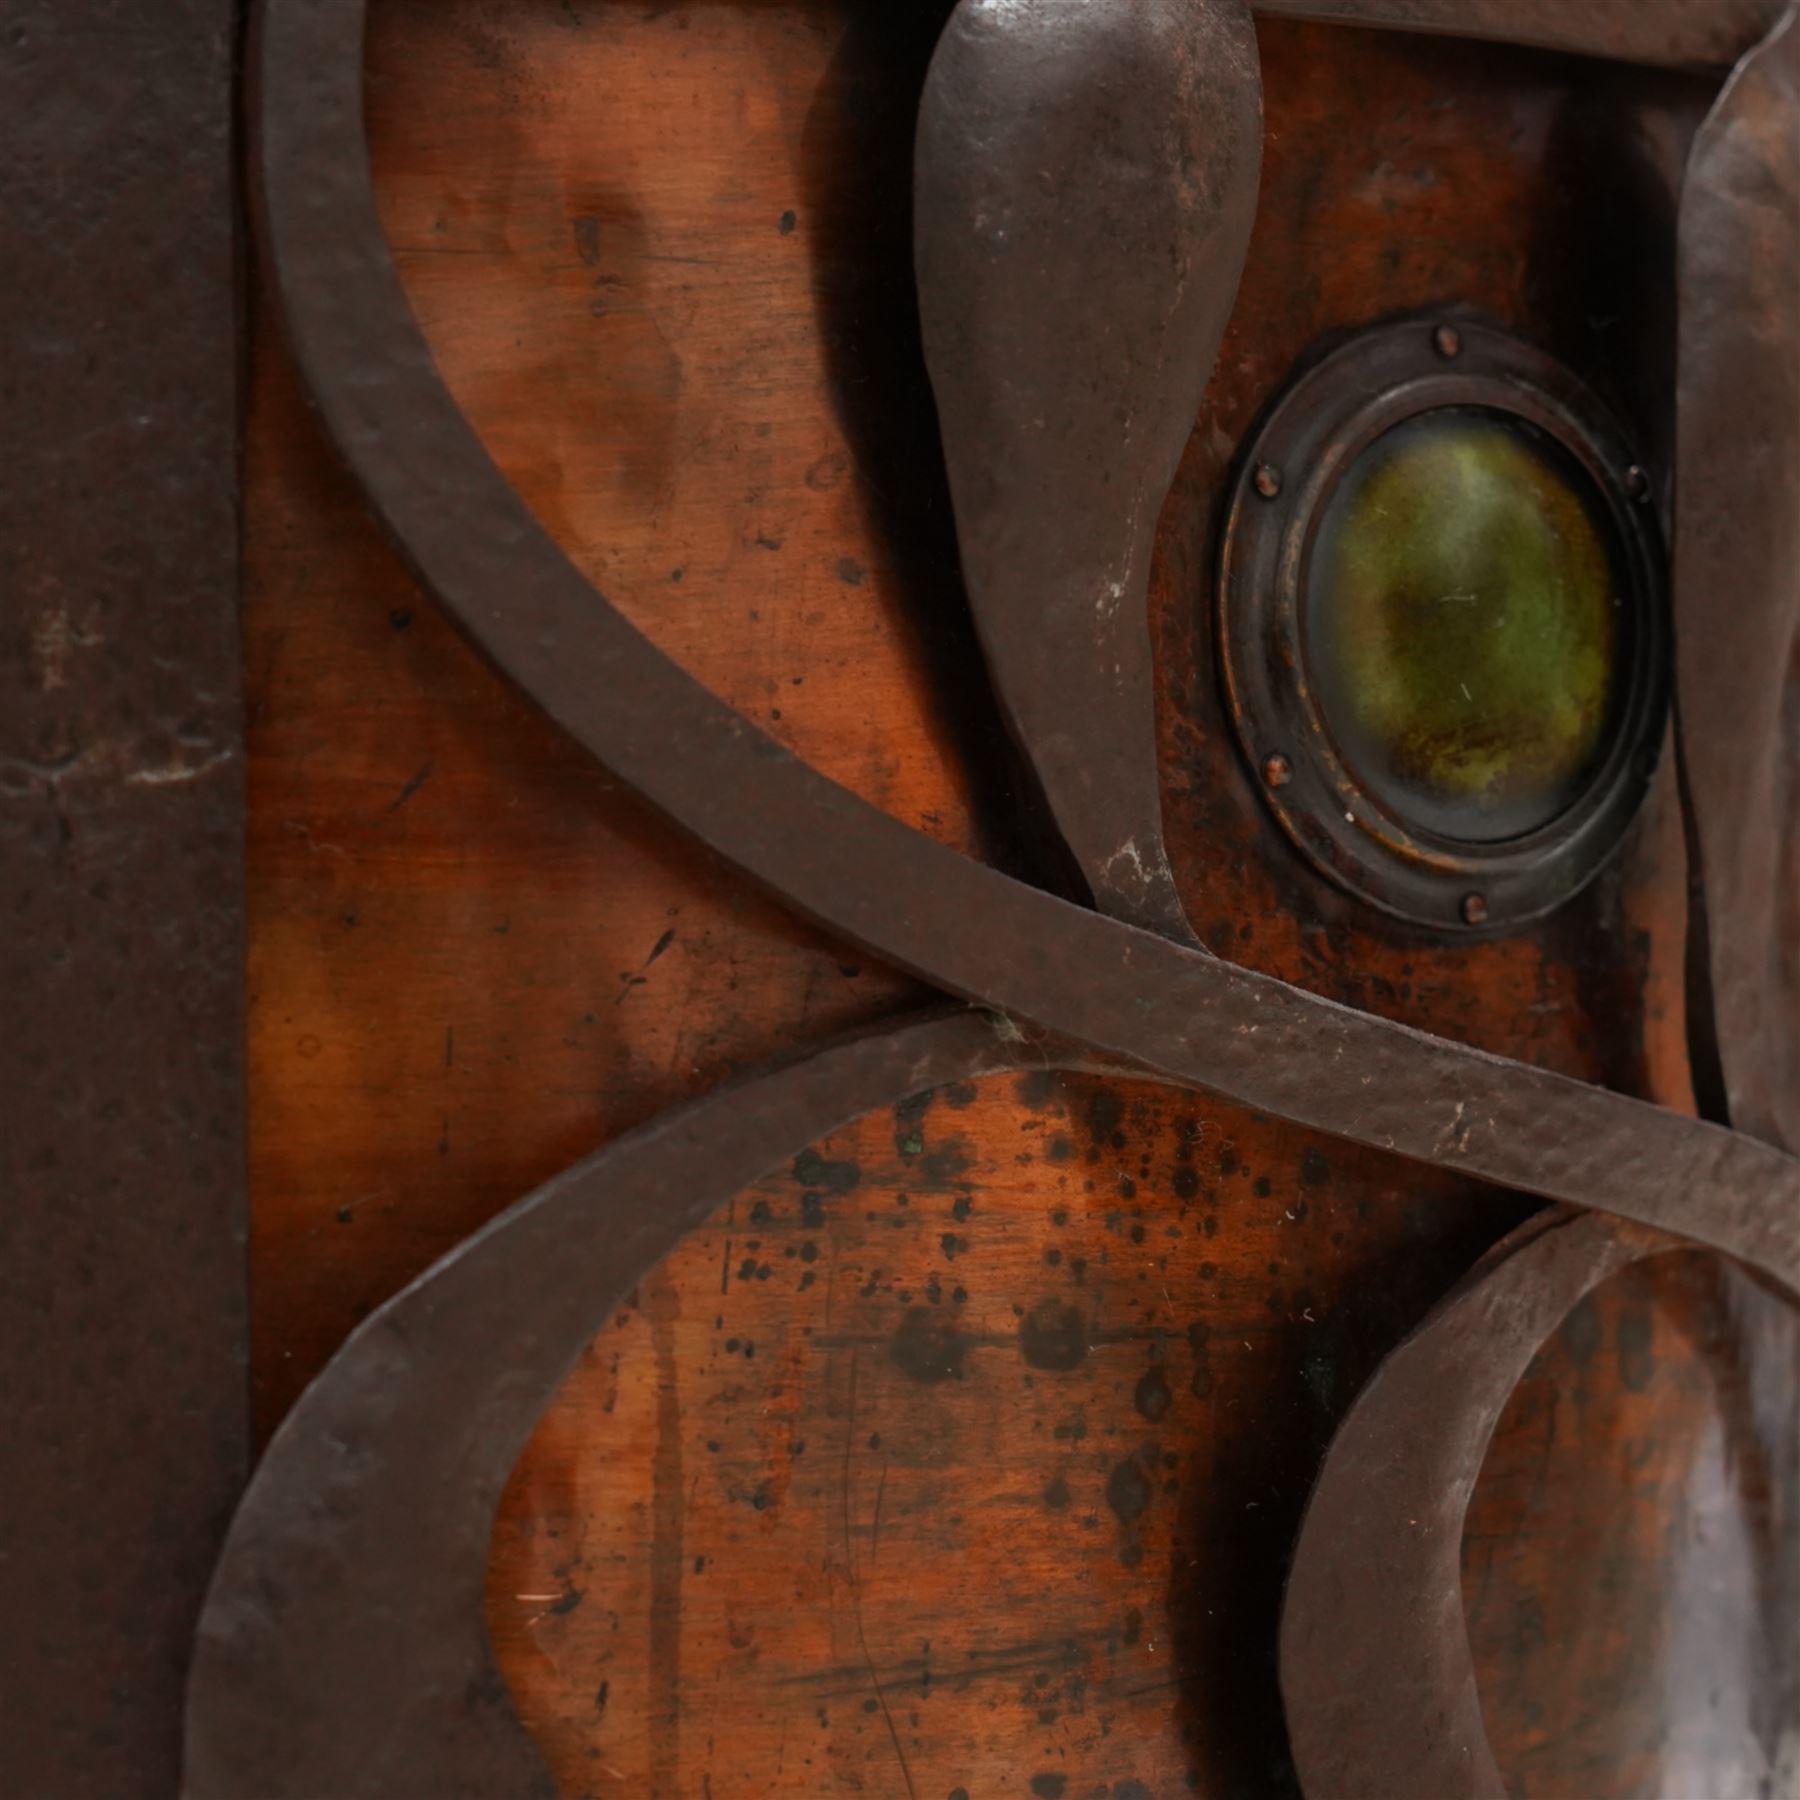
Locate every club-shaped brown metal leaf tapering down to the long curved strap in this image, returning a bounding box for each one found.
[916,0,1262,941]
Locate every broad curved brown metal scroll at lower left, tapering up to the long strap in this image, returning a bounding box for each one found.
[184,1012,1080,1800]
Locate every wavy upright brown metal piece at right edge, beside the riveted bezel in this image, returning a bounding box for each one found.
[1674,11,1800,1148]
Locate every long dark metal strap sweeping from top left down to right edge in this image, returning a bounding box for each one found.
[259,0,1800,1289]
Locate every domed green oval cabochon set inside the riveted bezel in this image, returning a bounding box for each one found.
[1305,407,1625,842]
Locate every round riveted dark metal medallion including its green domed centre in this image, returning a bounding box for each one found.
[1219,319,1669,929]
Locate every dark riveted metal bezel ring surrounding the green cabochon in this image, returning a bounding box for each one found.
[1219,319,1669,932]
